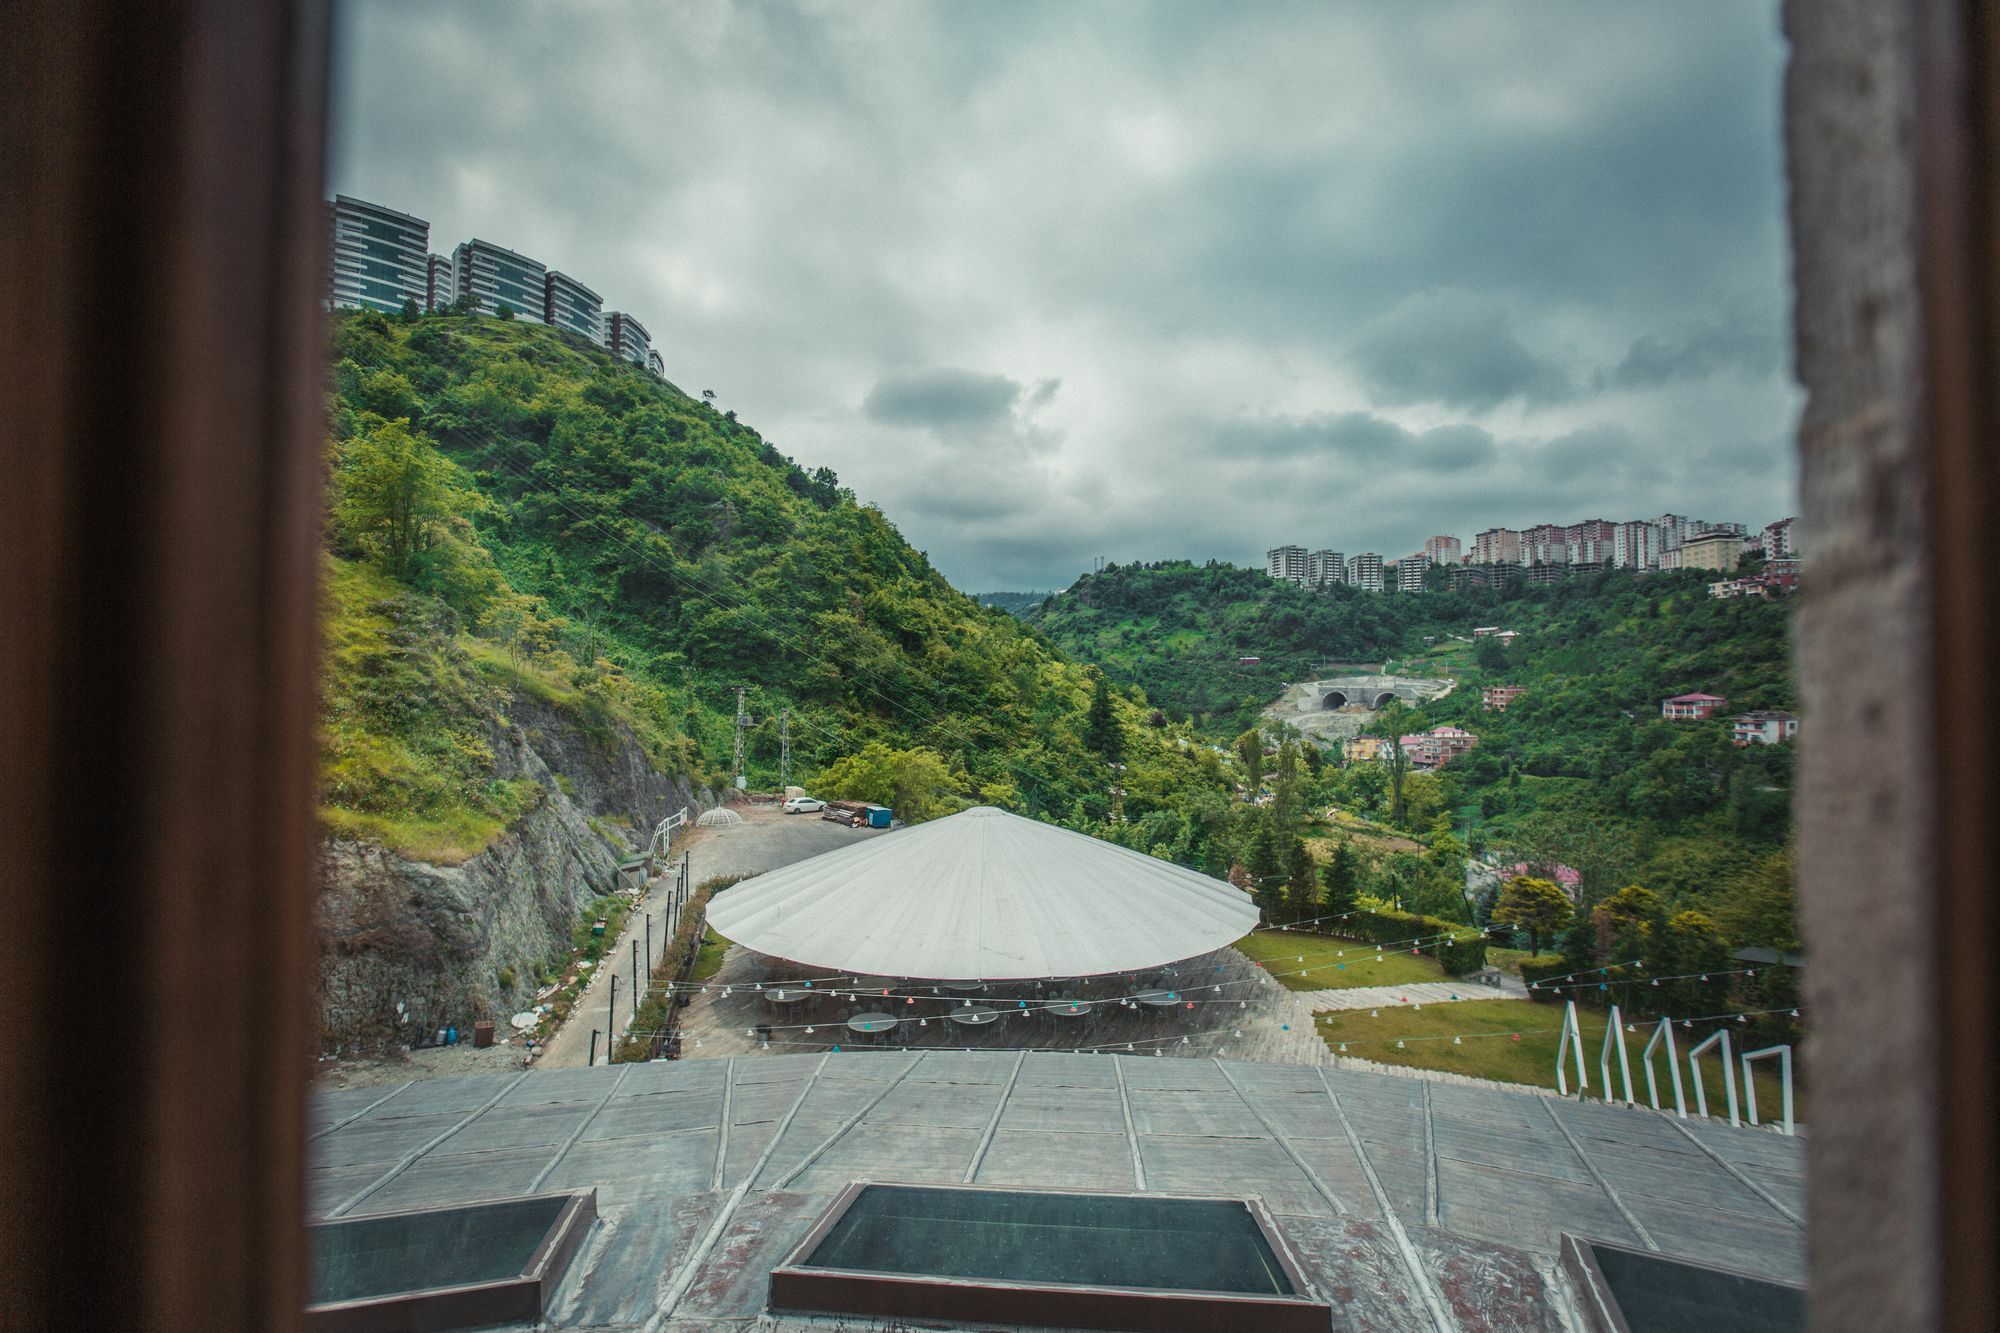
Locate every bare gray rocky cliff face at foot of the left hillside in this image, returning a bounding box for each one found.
[316,701,720,1053]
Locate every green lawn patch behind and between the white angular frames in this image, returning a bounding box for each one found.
[1316,1001,1806,1121]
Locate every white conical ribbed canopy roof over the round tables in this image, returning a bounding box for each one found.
[708,807,1258,981]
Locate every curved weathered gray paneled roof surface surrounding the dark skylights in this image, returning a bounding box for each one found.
[310,1051,1804,1329]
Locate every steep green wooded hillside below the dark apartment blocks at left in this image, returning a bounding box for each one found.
[324,312,1226,859]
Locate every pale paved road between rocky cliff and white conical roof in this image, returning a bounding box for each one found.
[534,805,882,1069]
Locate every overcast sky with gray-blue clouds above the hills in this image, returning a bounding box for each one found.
[328,0,1800,592]
